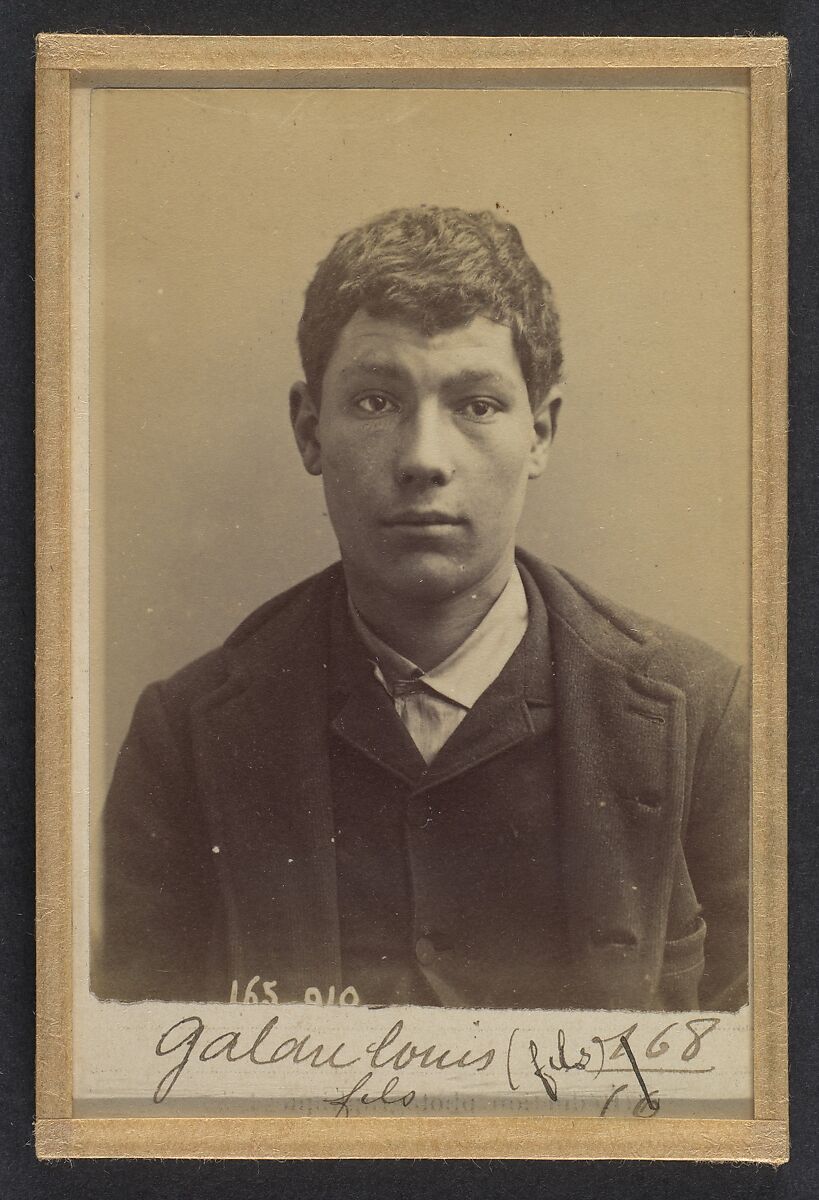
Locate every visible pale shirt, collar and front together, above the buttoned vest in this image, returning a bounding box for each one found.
[349,566,528,766]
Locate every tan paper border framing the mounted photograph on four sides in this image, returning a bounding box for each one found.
[35,34,788,1163]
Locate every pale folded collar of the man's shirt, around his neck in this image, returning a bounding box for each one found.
[349,566,528,708]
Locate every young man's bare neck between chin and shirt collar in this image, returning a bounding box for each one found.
[345,552,514,671]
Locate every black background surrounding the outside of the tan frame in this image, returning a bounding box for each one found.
[0,0,819,1200]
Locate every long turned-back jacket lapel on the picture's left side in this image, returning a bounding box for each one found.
[192,572,340,1001]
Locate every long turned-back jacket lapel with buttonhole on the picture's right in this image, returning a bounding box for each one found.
[518,559,686,1008]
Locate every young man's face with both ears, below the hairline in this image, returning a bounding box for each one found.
[291,310,558,604]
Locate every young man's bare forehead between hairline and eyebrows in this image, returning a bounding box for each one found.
[327,308,522,380]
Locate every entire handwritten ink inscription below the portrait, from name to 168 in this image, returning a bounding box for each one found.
[154,1012,721,1117]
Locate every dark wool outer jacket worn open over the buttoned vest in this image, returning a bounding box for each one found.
[92,553,749,1010]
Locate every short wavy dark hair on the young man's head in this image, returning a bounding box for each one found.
[299,205,563,407]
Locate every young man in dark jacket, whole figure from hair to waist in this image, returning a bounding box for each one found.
[92,206,749,1010]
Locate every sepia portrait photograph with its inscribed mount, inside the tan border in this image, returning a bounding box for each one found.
[35,38,784,1157]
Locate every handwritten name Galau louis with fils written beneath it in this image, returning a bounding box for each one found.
[154,1015,495,1115]
